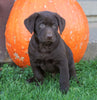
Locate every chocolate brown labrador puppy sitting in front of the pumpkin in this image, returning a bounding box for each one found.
[24,11,76,93]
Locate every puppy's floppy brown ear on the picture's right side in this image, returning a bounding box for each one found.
[55,14,65,34]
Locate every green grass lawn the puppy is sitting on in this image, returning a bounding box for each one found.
[0,60,97,100]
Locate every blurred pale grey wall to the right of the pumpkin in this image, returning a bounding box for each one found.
[77,0,97,59]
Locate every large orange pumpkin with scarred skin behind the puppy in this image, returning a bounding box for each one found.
[5,0,89,68]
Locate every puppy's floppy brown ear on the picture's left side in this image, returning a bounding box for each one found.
[24,13,38,33]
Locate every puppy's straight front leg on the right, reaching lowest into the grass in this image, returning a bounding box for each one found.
[59,59,69,93]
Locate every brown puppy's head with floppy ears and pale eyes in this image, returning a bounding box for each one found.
[24,11,65,43]
